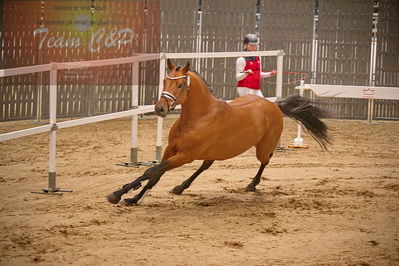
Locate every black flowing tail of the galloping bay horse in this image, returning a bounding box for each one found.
[277,95,331,150]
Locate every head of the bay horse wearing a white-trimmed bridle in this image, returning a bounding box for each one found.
[155,59,190,117]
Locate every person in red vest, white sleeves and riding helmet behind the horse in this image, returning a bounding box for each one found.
[236,34,277,98]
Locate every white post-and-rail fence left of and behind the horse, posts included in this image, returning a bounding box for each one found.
[0,50,284,194]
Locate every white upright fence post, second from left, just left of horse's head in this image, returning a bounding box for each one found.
[130,62,139,165]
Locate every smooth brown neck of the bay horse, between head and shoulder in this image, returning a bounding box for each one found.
[180,77,217,120]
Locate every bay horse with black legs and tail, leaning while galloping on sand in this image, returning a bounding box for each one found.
[107,59,330,205]
